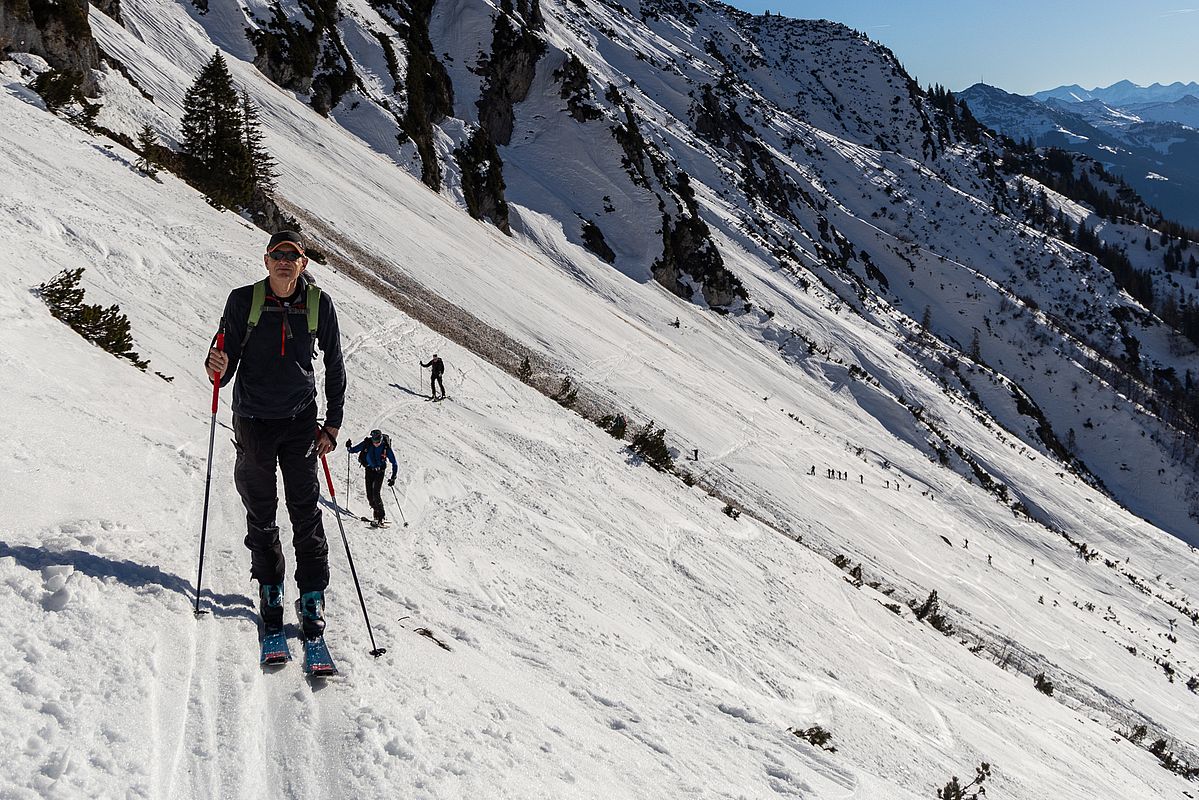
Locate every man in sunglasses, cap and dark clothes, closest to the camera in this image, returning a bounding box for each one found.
[206,230,345,638]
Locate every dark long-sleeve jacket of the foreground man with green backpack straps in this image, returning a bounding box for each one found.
[213,275,345,428]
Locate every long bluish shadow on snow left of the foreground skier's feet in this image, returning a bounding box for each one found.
[0,541,258,622]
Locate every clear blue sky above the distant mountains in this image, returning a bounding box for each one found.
[731,0,1199,95]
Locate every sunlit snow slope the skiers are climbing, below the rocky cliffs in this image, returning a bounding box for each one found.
[0,28,1199,799]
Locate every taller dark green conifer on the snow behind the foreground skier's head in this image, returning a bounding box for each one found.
[182,52,254,209]
